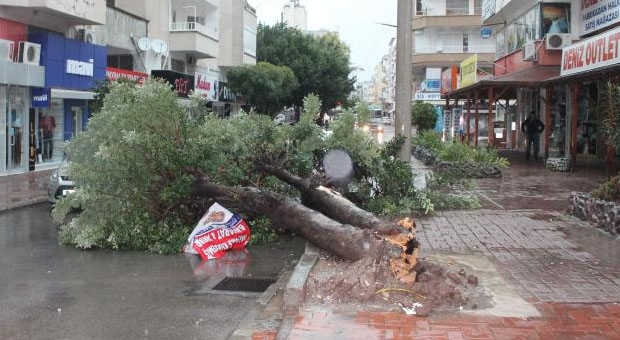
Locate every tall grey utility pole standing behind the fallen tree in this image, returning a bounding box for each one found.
[394,0,413,162]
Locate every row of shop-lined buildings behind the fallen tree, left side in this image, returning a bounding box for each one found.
[0,0,257,176]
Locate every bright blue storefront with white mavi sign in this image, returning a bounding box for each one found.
[31,32,107,169]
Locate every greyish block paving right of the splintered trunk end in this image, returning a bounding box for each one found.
[416,210,620,303]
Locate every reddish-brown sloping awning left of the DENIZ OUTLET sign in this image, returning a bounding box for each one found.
[444,66,560,98]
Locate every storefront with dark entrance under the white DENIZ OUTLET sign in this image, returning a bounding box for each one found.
[546,23,620,167]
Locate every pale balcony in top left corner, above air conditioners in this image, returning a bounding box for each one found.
[0,0,106,27]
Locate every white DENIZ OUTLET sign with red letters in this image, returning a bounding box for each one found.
[560,28,620,76]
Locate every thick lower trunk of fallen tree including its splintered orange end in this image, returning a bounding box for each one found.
[191,170,418,283]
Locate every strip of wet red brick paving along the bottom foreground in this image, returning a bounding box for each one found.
[284,303,620,340]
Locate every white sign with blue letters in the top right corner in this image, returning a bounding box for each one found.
[580,0,620,35]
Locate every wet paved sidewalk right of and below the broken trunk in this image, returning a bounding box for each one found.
[252,153,620,340]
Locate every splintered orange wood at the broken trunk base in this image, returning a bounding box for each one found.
[386,217,420,284]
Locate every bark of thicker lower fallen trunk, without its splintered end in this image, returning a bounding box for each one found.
[194,175,404,261]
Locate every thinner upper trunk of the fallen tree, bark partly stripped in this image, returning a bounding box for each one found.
[260,164,407,235]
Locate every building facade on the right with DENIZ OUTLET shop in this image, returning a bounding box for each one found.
[447,0,620,169]
